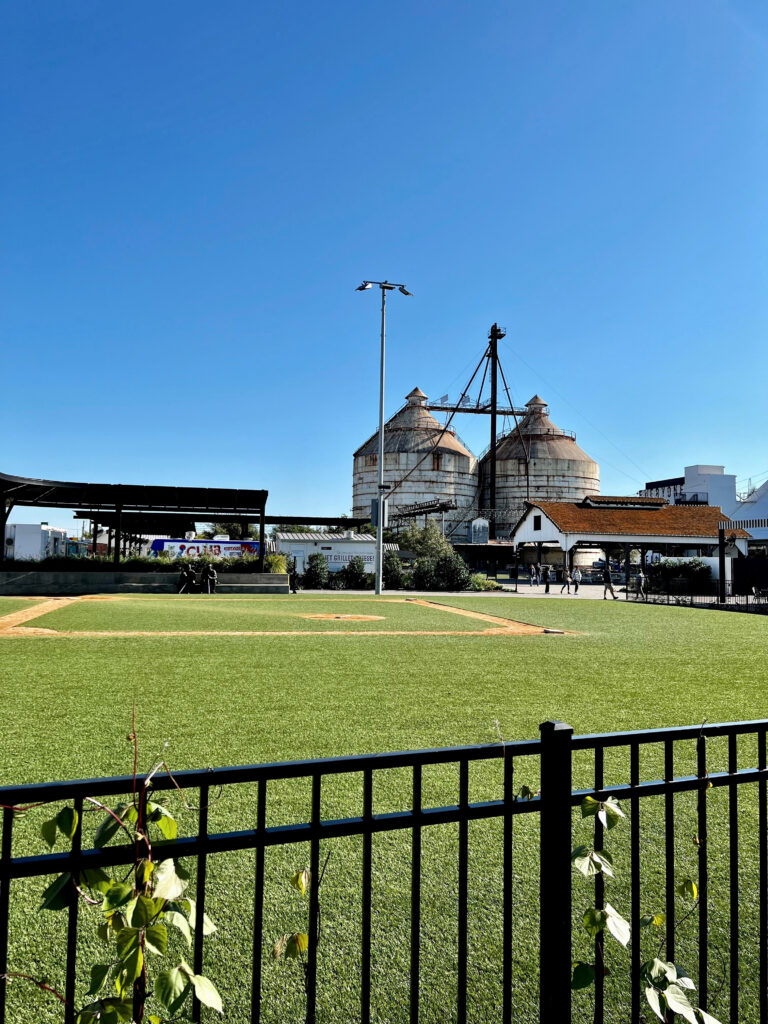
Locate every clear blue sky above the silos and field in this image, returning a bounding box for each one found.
[0,0,768,521]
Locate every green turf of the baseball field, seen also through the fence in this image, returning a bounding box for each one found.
[0,596,768,1024]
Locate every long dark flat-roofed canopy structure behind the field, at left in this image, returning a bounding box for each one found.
[0,473,268,570]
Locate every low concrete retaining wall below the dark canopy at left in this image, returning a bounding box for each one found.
[0,569,290,597]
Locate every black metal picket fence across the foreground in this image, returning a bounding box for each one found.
[0,720,768,1024]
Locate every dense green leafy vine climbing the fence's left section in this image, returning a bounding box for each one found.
[0,725,223,1024]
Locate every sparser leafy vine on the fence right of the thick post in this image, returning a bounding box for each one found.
[570,797,720,1024]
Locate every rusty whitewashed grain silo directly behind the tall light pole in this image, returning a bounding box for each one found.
[352,387,478,516]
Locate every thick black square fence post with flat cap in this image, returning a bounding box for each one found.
[539,722,573,1024]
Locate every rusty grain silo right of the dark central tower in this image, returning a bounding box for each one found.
[480,394,600,535]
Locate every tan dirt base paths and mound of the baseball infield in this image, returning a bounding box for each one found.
[0,595,562,638]
